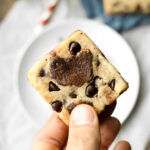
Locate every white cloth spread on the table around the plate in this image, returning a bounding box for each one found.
[0,0,150,150]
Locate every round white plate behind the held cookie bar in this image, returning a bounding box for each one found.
[16,19,140,126]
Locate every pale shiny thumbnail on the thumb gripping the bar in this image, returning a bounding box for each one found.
[72,106,94,126]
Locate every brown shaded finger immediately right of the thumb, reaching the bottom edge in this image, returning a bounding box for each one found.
[100,117,121,150]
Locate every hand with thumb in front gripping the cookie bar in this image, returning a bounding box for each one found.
[32,103,131,150]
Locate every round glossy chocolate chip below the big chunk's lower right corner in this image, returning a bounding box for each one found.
[85,83,98,97]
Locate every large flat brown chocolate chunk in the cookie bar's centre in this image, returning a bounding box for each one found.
[50,49,93,87]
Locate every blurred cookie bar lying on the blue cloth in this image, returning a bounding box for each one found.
[103,0,150,15]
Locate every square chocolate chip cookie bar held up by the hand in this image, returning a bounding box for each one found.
[28,30,128,124]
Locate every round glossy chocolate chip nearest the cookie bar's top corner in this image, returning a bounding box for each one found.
[69,41,81,55]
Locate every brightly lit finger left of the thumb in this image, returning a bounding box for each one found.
[32,113,68,150]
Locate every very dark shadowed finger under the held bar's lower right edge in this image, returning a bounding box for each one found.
[99,101,117,122]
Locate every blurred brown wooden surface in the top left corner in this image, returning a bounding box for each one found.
[0,0,16,21]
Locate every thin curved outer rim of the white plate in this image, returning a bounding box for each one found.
[13,18,141,126]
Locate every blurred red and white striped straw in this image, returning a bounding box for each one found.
[33,0,59,35]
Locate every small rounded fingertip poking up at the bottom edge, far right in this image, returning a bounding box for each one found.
[114,141,131,150]
